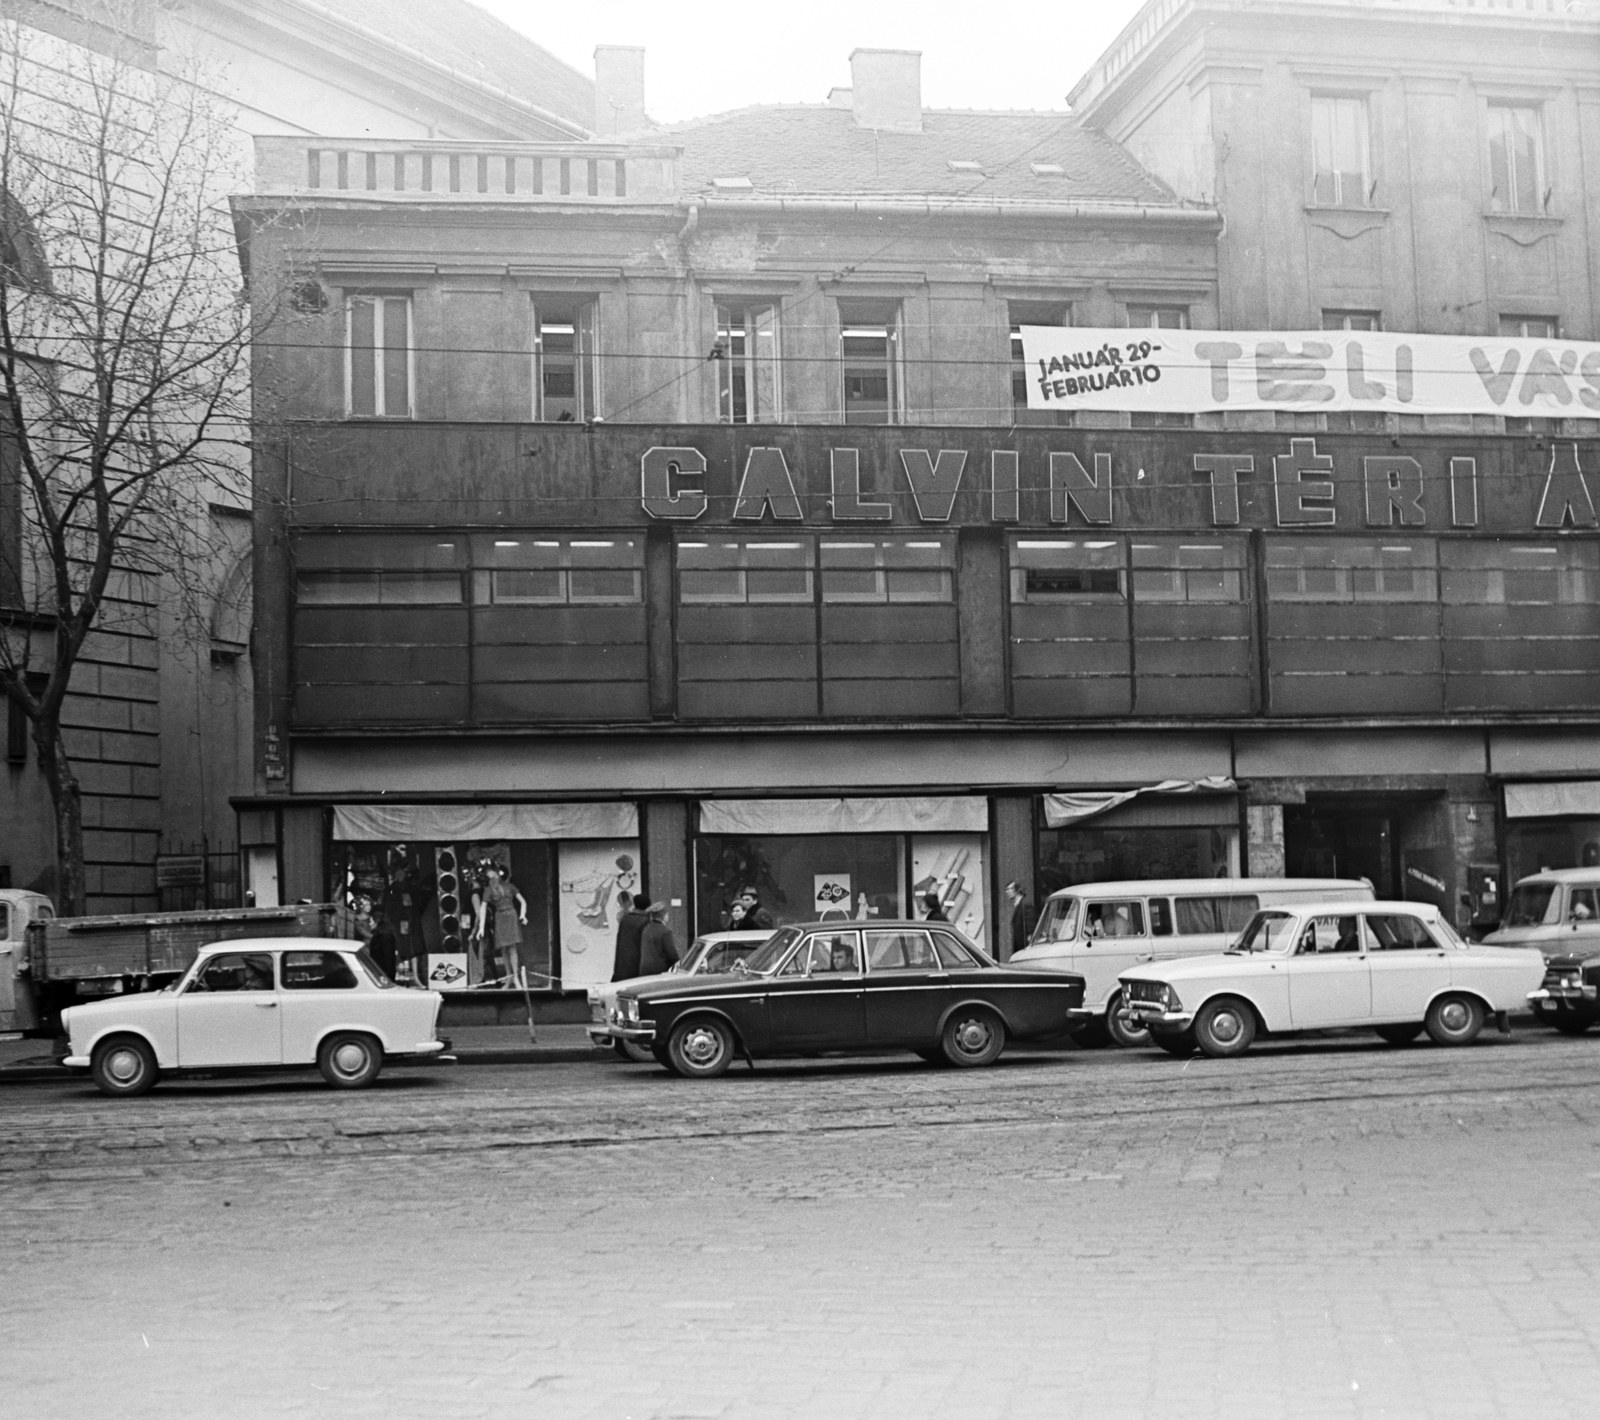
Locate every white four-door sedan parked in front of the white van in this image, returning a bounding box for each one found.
[1122,902,1544,1055]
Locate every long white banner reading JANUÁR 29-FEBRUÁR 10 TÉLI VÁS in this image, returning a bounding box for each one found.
[1022,326,1600,419]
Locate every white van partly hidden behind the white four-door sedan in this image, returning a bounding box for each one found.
[1011,878,1373,1046]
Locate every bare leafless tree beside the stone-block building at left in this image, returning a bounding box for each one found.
[0,0,251,913]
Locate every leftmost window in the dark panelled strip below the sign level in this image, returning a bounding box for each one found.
[294,534,466,606]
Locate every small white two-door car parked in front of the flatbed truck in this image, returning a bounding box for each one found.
[61,937,448,1095]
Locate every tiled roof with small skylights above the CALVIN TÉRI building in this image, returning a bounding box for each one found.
[659,104,1178,206]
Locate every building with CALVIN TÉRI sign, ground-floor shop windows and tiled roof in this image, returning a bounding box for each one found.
[238,30,1600,987]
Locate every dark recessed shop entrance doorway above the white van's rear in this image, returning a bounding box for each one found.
[1283,793,1448,900]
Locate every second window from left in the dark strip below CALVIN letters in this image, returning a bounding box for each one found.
[472,534,645,606]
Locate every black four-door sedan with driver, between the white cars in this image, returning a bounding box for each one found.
[611,921,1083,1078]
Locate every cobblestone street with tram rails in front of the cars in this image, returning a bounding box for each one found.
[0,1028,1600,1420]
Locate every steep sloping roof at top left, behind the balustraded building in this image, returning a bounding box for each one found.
[291,0,595,128]
